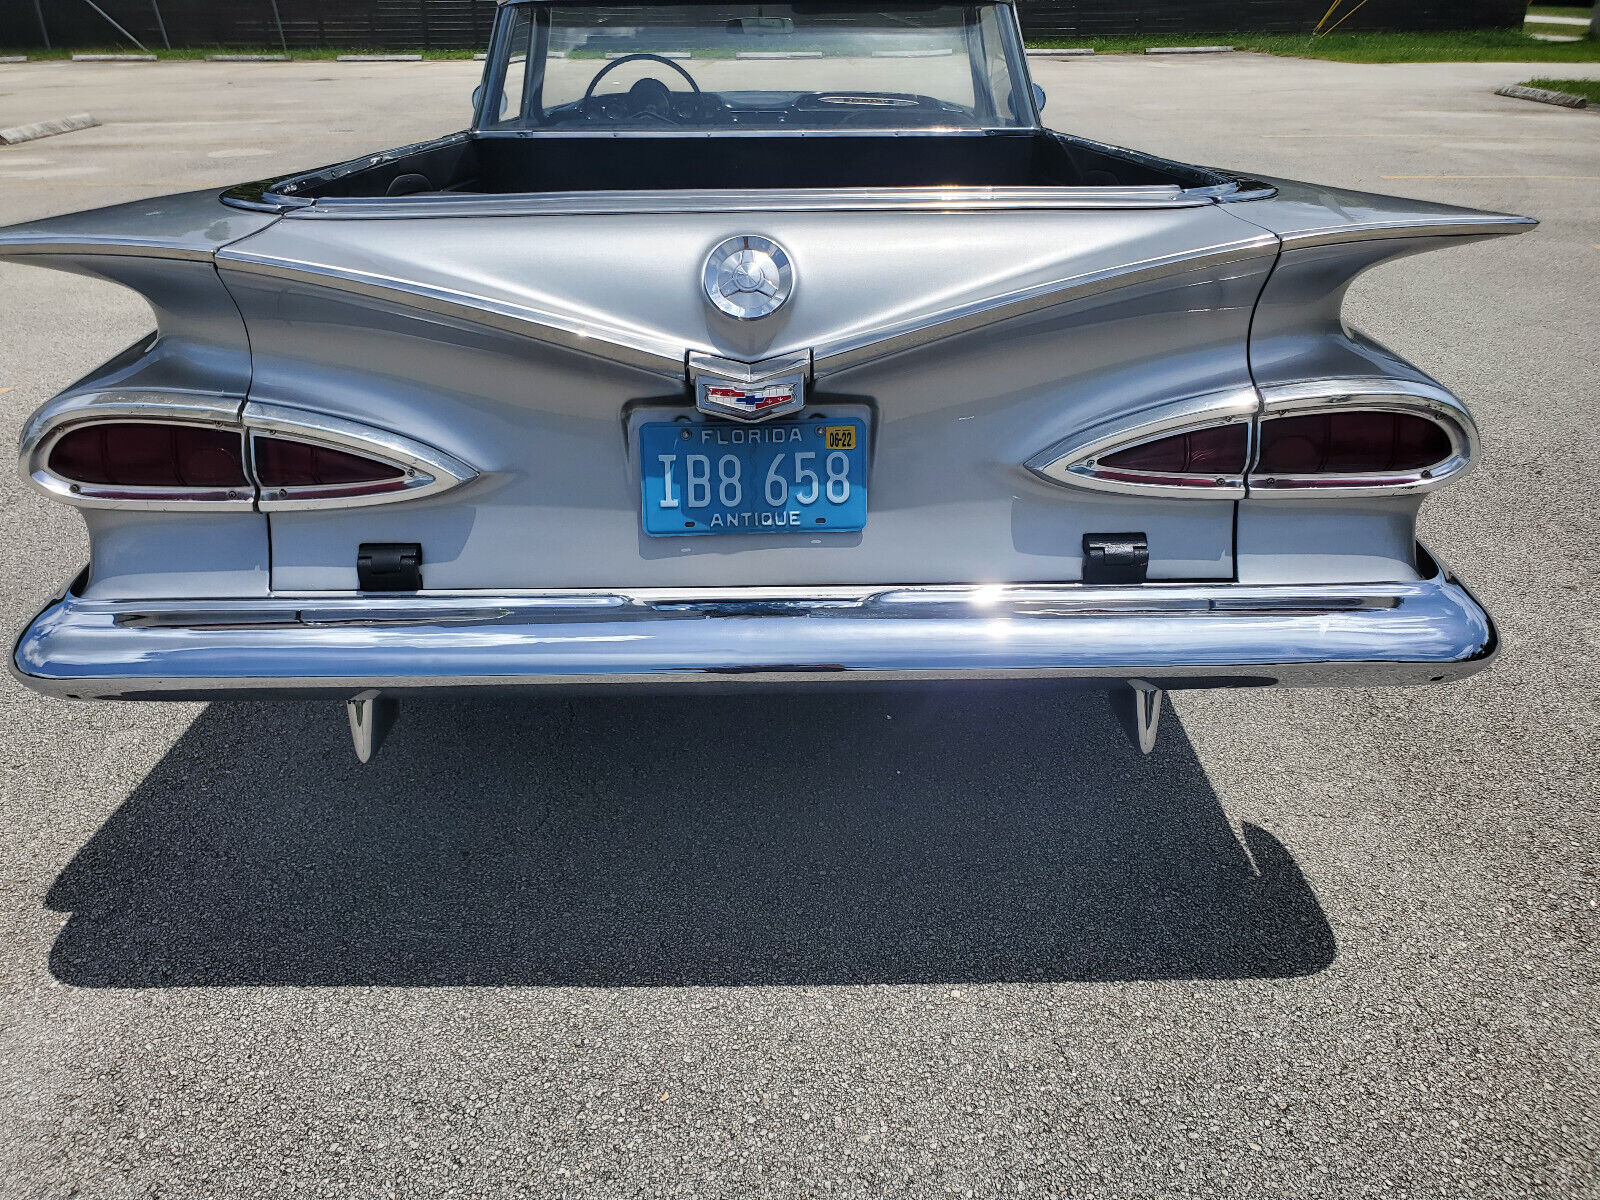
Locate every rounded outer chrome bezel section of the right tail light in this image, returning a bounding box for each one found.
[1250,378,1480,499]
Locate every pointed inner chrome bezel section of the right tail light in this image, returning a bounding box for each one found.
[1024,387,1261,501]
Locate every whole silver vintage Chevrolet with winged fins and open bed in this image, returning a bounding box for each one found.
[0,0,1534,760]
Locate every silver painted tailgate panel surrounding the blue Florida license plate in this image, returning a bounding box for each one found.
[219,206,1277,590]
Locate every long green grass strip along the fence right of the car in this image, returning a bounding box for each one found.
[1029,30,1600,62]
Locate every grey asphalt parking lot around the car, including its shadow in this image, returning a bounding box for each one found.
[0,54,1600,1200]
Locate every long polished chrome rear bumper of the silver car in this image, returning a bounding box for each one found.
[14,558,1496,699]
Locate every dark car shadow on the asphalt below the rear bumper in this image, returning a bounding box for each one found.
[46,685,1334,987]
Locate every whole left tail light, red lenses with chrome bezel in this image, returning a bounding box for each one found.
[22,394,477,512]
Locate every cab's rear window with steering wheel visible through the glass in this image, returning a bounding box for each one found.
[478,3,1035,130]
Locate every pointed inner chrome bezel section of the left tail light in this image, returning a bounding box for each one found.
[243,400,478,512]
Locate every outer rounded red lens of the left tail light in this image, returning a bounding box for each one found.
[48,421,248,488]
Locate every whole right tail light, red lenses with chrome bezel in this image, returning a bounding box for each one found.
[1029,379,1477,499]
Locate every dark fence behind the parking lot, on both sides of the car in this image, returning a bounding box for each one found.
[0,0,1525,50]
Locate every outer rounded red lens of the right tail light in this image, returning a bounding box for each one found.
[1253,411,1454,478]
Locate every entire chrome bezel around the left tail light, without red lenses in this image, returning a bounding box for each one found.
[18,390,478,512]
